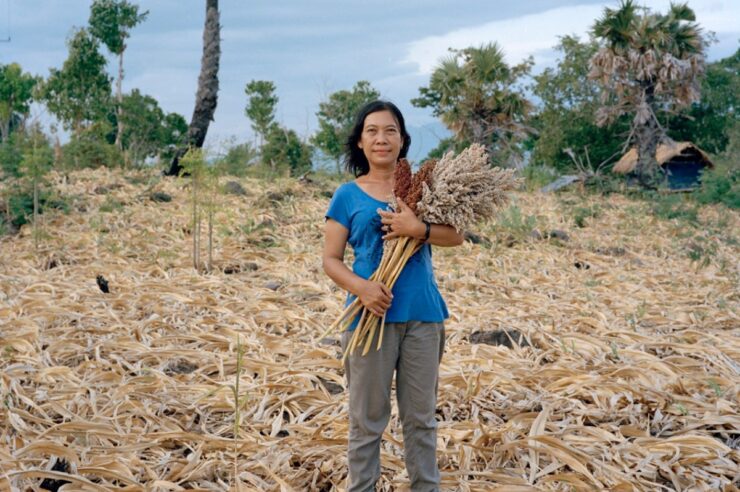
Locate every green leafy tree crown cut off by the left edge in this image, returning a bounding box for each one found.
[0,63,39,142]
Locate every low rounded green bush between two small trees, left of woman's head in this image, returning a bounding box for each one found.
[262,123,312,175]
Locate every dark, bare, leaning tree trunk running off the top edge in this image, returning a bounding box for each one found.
[165,0,221,176]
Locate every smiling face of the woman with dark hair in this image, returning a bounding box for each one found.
[357,110,403,166]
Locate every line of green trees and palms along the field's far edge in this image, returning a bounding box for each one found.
[0,0,740,184]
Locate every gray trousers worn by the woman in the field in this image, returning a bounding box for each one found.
[342,321,445,492]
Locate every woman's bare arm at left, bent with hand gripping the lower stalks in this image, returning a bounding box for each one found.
[322,219,393,317]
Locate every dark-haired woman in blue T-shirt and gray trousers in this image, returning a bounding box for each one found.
[323,101,463,492]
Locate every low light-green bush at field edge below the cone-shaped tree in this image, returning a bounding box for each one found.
[62,120,123,170]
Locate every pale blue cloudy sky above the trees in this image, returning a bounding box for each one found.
[0,0,740,161]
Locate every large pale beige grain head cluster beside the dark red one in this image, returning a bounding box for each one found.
[417,144,519,232]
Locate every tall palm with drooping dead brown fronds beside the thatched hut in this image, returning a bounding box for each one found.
[589,0,706,187]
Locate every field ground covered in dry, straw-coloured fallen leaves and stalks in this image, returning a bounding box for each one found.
[0,169,740,491]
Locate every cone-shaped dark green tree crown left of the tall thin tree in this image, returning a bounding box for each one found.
[41,29,111,133]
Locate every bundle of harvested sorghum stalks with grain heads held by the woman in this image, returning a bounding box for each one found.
[327,144,519,360]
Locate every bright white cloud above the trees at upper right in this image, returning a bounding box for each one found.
[401,0,740,74]
